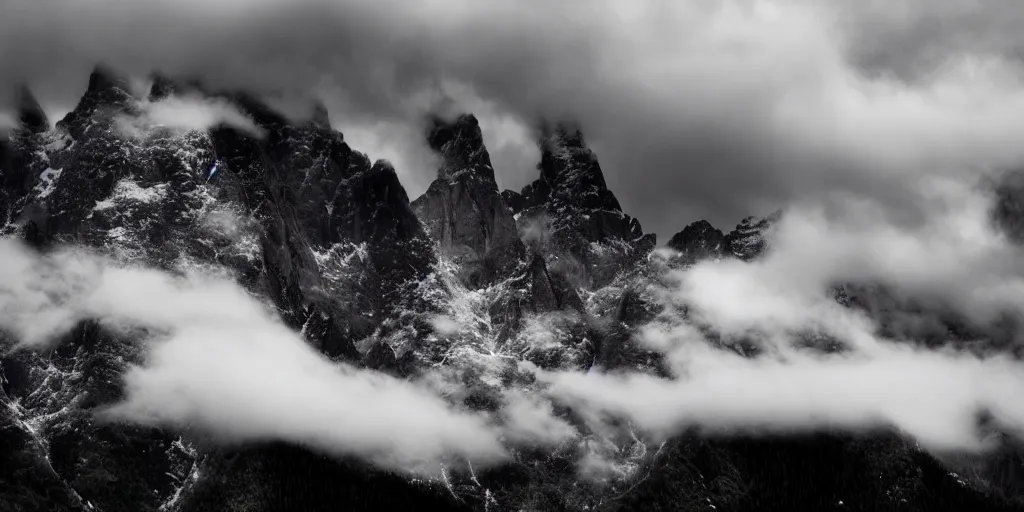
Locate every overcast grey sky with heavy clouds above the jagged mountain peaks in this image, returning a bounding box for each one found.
[0,0,1024,243]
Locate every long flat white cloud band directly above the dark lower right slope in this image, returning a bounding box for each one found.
[541,345,1024,452]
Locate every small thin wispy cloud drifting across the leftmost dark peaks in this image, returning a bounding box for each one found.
[117,95,263,137]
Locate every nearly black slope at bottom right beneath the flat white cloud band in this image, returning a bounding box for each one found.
[604,435,1018,512]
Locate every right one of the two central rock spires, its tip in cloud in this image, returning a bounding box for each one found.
[504,119,656,289]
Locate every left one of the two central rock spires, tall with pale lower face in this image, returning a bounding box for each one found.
[413,115,525,288]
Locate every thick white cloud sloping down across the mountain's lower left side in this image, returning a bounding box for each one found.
[0,240,507,474]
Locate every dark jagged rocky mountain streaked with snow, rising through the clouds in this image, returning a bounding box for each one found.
[0,68,1024,512]
